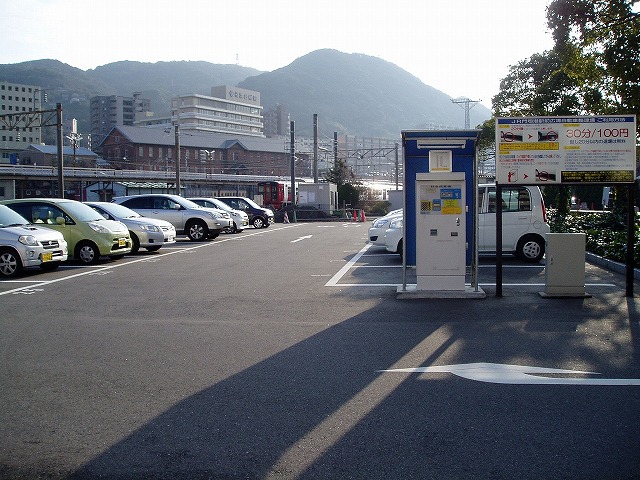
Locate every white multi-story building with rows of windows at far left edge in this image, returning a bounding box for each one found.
[0,81,42,163]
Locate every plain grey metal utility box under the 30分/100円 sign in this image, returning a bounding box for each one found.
[543,233,586,297]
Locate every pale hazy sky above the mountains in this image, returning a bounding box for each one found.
[0,0,552,107]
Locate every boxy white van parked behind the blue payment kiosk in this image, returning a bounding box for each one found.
[384,184,549,262]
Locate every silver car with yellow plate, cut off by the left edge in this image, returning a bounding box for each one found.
[0,205,68,278]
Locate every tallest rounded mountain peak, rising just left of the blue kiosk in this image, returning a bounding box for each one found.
[238,49,491,138]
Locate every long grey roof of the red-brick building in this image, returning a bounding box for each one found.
[103,125,288,153]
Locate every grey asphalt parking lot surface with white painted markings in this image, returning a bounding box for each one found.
[0,222,640,479]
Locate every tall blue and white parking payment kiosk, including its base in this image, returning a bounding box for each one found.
[398,130,486,298]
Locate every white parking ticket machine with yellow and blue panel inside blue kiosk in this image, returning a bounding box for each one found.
[416,172,467,291]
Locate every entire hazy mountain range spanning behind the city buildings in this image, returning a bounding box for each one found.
[0,49,491,139]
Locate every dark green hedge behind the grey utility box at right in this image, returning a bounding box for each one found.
[547,209,640,268]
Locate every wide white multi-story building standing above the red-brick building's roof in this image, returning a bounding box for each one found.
[171,85,264,137]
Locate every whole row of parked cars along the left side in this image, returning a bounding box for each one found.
[0,194,273,278]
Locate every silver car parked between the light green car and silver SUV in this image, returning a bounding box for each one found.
[84,202,176,253]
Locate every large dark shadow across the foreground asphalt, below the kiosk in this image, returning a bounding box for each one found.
[70,290,640,480]
